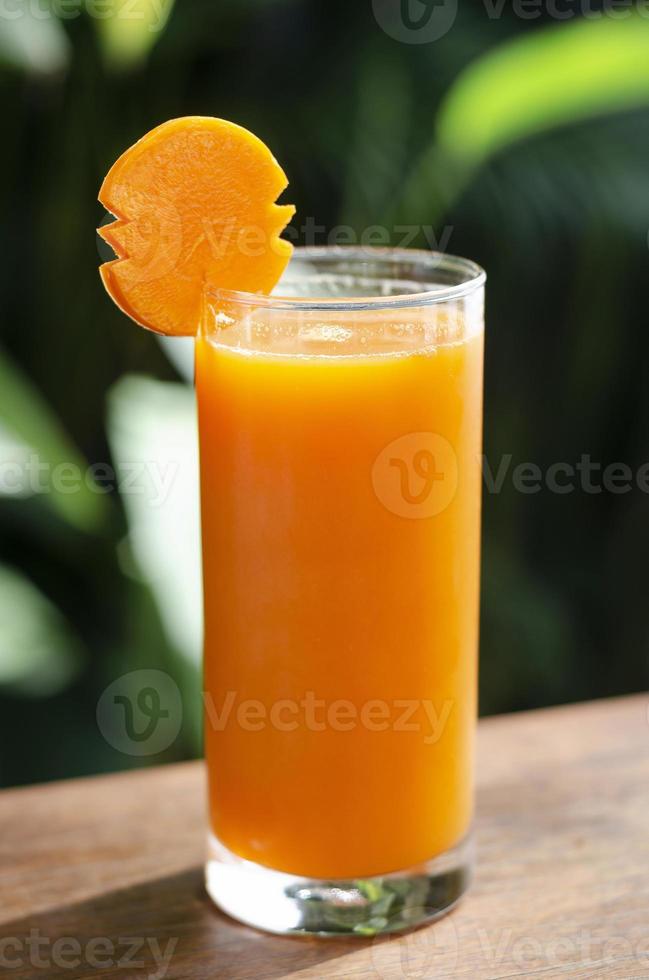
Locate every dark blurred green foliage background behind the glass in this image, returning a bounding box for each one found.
[0,0,649,785]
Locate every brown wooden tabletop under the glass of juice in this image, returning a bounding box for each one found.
[0,696,649,980]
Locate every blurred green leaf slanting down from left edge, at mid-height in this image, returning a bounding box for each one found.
[0,350,106,531]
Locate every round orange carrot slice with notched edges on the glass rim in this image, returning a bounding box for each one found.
[98,116,295,336]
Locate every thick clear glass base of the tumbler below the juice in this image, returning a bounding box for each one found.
[205,835,473,936]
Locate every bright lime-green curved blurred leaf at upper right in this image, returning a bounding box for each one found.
[402,10,649,220]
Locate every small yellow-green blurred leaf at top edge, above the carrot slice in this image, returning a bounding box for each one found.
[97,0,174,69]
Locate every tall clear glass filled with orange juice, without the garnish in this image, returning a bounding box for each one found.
[196,248,485,935]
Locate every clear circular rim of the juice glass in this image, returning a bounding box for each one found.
[205,245,487,313]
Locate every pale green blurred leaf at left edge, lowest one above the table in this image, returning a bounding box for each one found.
[0,565,82,697]
